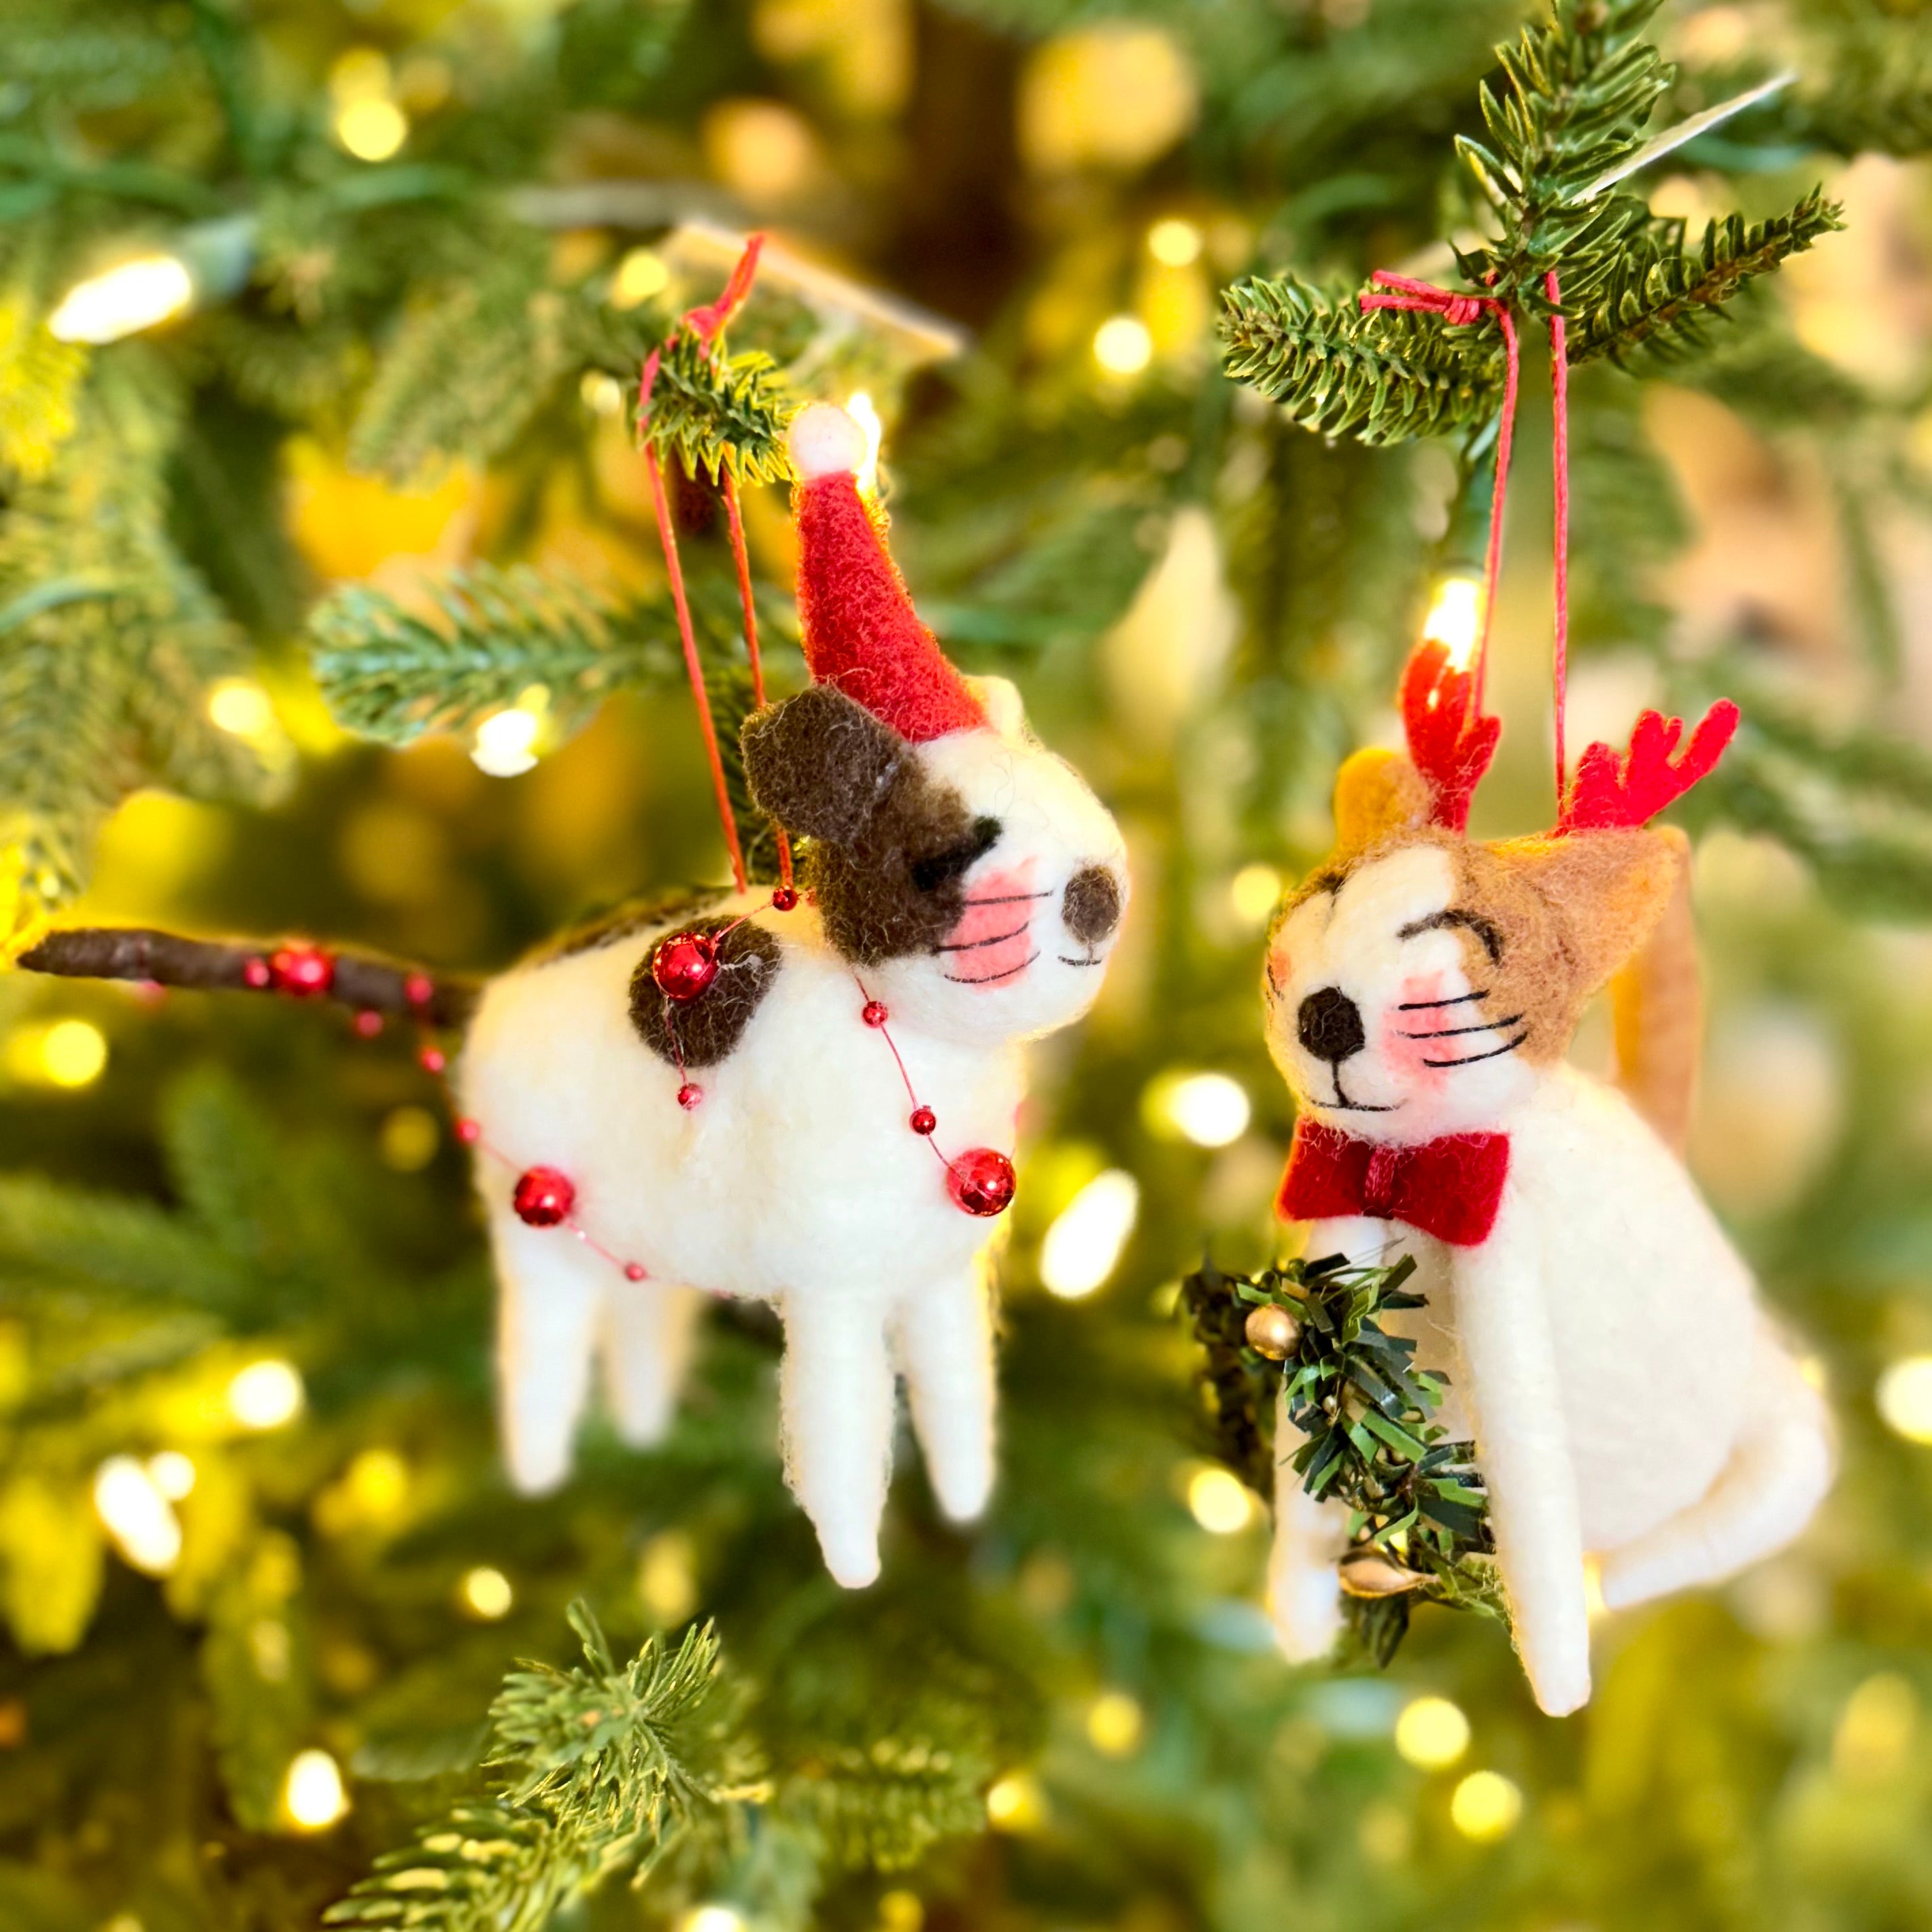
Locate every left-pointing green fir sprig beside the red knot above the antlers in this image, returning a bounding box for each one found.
[1221,274,1501,443]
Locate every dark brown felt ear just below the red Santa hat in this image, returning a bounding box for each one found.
[740,684,912,846]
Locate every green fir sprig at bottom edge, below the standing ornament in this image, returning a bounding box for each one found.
[322,1599,744,1932]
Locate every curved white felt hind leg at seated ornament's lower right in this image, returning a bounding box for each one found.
[1604,1321,1833,1610]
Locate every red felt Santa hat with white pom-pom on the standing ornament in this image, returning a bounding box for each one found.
[786,402,987,744]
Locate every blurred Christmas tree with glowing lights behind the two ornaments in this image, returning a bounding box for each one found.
[0,0,1932,1932]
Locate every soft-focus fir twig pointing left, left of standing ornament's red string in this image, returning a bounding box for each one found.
[309,564,684,744]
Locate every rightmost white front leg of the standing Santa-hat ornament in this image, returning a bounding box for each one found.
[893,1264,995,1523]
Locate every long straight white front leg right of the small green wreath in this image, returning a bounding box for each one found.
[1451,1221,1590,1718]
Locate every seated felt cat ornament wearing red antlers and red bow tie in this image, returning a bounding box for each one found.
[1264,643,1833,1714]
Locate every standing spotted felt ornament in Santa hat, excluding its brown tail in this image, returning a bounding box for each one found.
[458,404,1126,1586]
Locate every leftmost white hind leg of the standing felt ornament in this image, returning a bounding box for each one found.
[489,1206,611,1495]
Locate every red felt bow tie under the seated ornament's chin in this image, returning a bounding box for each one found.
[1275,1115,1509,1248]
